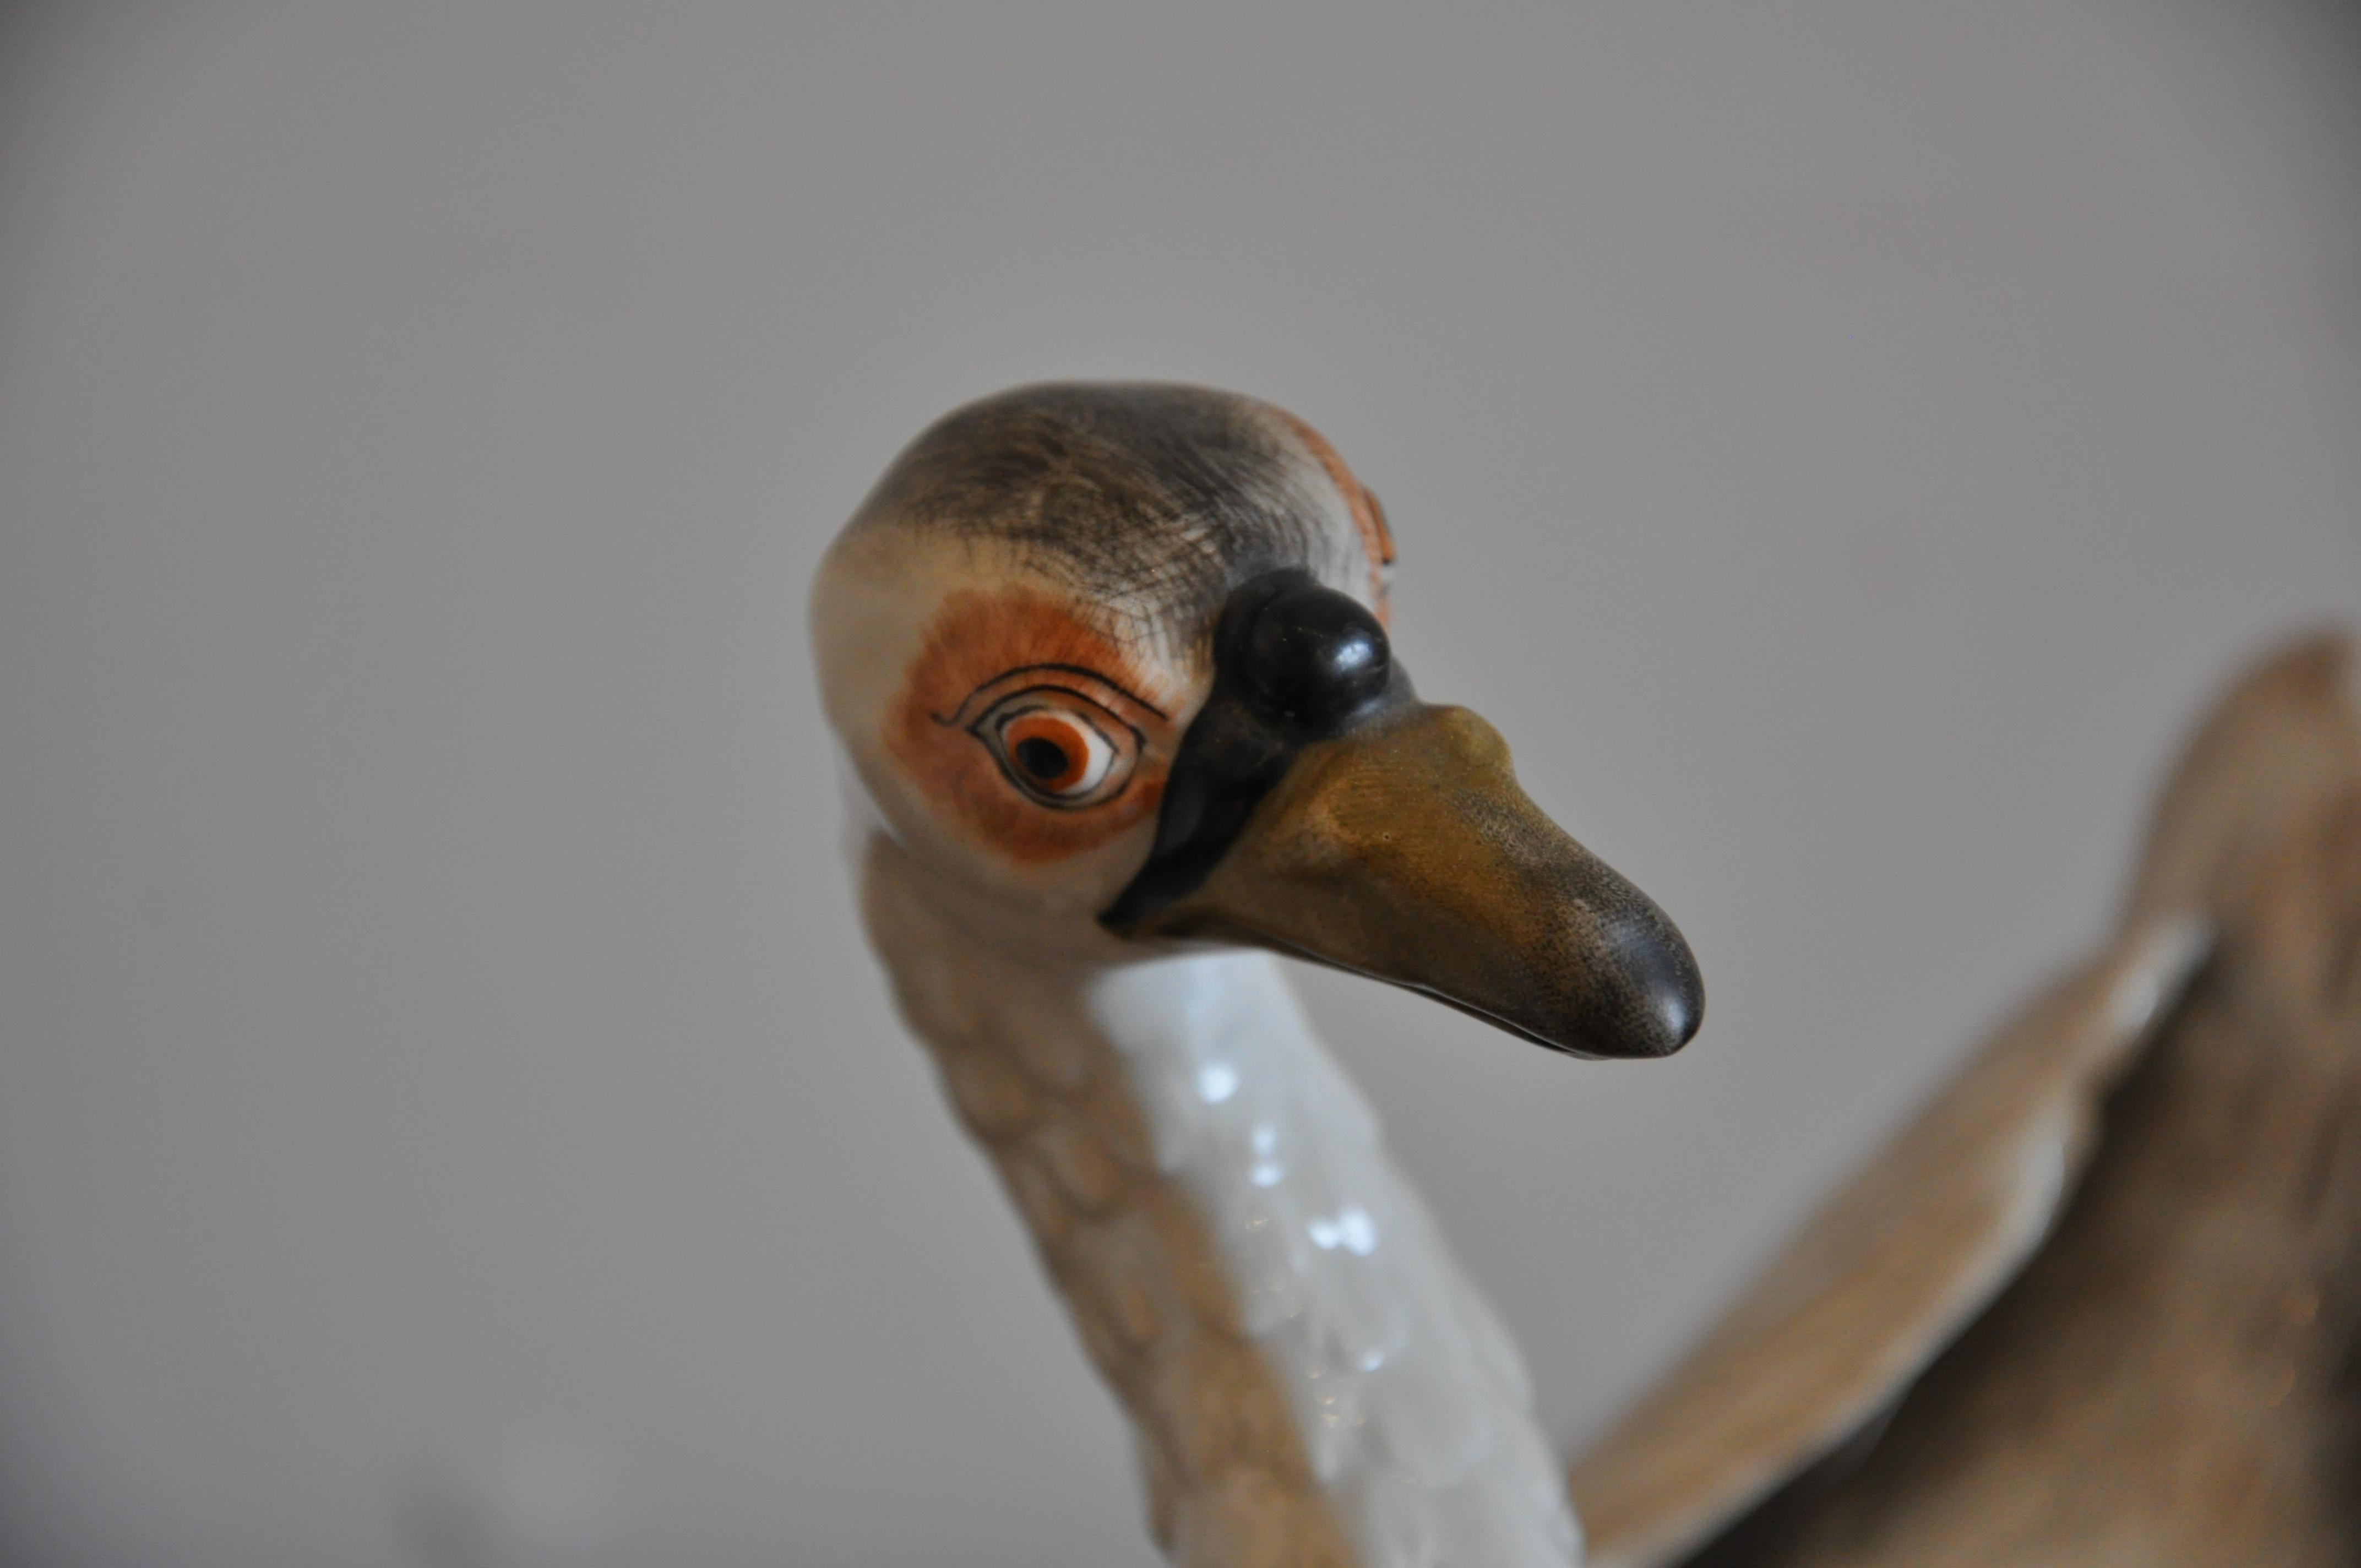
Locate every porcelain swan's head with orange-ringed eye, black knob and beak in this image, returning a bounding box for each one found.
[812,383,1705,1055]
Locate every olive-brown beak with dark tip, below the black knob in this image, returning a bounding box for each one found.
[1109,699,1705,1058]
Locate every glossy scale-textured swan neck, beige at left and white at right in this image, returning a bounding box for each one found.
[867,839,1580,1568]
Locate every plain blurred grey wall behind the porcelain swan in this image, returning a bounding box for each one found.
[0,0,2361,1568]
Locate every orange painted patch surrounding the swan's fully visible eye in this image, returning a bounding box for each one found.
[885,588,1176,864]
